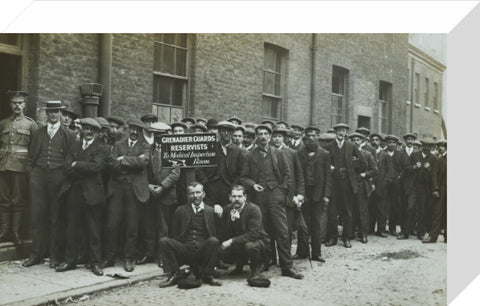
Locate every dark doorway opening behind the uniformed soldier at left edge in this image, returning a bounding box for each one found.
[0,53,22,119]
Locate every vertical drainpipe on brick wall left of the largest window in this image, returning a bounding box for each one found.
[98,34,112,117]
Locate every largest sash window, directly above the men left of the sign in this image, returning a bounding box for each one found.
[152,34,188,122]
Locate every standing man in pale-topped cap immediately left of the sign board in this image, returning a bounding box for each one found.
[136,122,180,265]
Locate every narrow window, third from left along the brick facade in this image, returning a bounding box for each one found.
[330,66,348,126]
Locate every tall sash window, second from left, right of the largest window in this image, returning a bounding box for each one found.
[262,44,288,120]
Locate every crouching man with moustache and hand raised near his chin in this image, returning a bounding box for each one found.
[219,185,270,278]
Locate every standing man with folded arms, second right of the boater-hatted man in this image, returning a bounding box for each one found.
[102,119,150,272]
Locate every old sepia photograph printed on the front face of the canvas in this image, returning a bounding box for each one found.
[0,33,447,305]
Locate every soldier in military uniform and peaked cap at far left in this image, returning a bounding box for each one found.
[0,91,37,244]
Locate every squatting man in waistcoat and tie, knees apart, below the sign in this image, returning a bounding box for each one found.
[159,182,221,288]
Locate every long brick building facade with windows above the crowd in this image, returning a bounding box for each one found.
[0,33,443,137]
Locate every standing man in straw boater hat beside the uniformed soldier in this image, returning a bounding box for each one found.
[22,101,75,268]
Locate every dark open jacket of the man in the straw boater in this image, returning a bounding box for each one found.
[25,124,75,172]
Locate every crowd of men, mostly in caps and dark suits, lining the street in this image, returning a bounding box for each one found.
[0,91,447,287]
